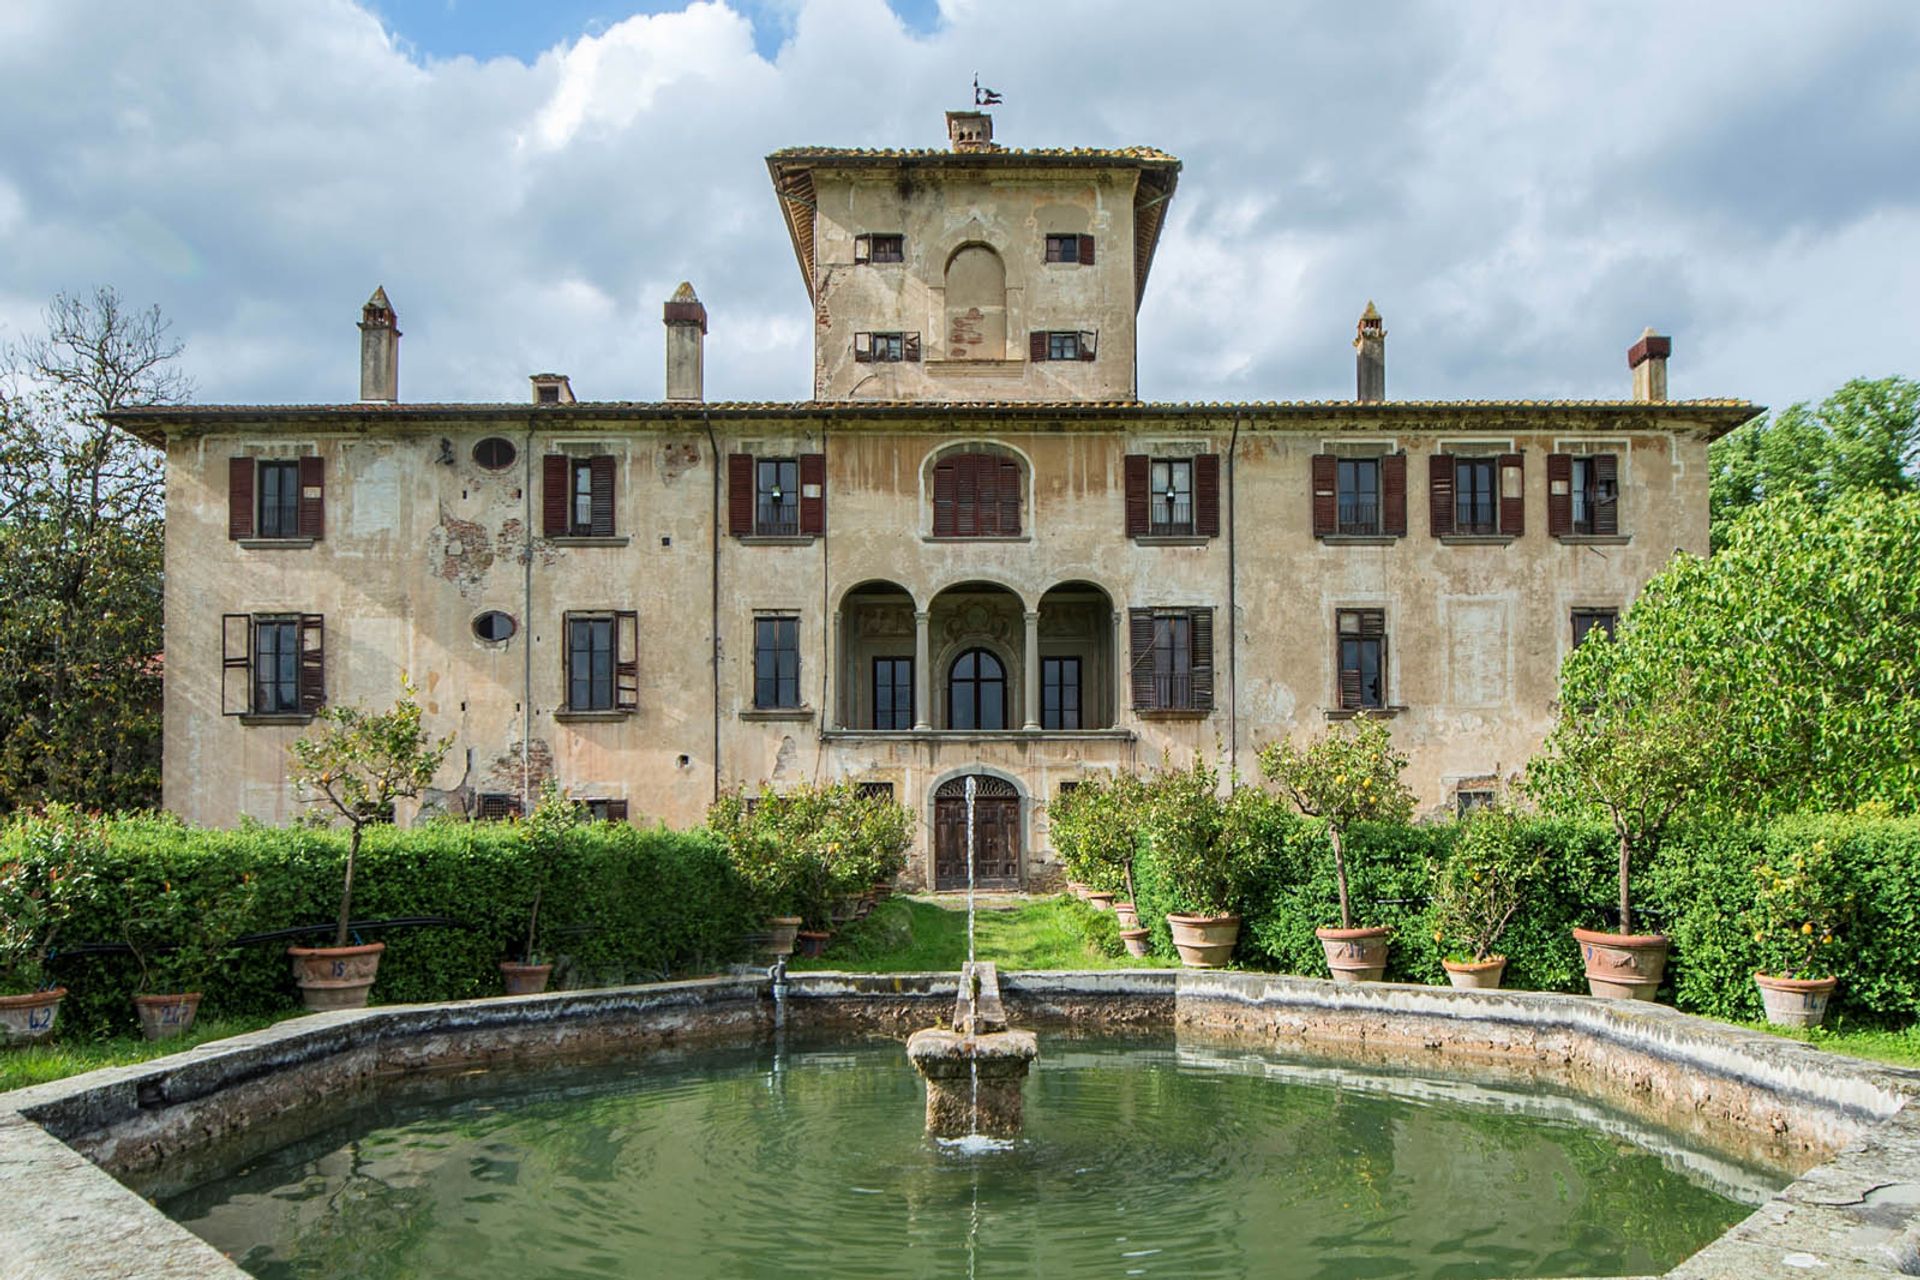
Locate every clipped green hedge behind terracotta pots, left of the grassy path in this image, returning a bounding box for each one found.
[11,818,753,1034]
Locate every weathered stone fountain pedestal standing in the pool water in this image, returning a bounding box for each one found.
[906,963,1041,1138]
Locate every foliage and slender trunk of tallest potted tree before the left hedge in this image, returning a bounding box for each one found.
[288,679,453,946]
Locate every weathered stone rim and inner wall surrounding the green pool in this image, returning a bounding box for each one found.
[0,969,1920,1280]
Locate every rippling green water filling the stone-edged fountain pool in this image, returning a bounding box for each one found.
[161,1036,1786,1280]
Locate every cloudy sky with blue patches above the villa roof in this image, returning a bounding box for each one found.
[0,0,1920,405]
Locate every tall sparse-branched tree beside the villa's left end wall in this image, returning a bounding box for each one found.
[0,288,192,812]
